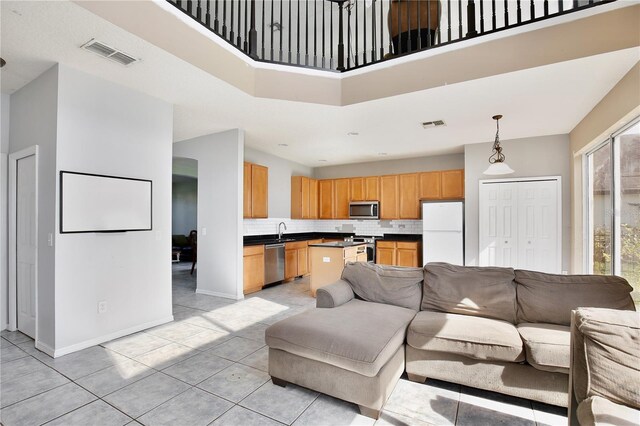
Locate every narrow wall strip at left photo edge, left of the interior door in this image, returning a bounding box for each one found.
[0,93,10,330]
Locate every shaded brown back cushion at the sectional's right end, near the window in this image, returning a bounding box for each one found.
[515,270,635,326]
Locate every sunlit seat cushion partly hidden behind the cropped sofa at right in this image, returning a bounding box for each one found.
[517,323,571,374]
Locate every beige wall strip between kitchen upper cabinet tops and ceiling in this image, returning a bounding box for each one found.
[313,154,464,179]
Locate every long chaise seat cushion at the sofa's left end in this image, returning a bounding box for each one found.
[265,300,416,377]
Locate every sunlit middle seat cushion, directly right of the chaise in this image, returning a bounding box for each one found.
[407,311,524,362]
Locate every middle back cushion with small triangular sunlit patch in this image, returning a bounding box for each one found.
[421,262,516,324]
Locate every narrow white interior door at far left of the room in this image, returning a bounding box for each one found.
[16,155,37,339]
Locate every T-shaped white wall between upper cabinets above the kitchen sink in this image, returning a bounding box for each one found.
[244,147,313,217]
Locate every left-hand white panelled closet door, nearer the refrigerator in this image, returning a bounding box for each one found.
[479,183,518,266]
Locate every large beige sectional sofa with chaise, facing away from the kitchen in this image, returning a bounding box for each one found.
[265,263,634,418]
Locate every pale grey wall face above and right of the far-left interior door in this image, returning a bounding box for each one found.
[9,66,58,353]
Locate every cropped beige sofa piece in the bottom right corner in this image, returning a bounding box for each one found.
[569,308,640,426]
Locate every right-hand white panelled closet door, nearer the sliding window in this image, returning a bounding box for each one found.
[517,181,562,273]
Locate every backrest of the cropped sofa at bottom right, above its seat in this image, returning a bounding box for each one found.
[570,308,640,409]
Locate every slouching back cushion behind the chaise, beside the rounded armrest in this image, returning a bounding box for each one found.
[342,262,423,311]
